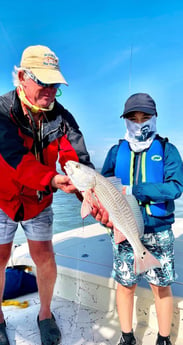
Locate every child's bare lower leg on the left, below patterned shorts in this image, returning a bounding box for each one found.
[116,284,136,333]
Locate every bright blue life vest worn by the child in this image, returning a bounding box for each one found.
[115,139,166,217]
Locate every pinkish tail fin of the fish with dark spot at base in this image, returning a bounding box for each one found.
[134,247,162,274]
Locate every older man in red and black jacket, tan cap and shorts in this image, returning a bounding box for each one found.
[0,45,93,345]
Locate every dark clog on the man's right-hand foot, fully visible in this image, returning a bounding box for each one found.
[37,314,61,345]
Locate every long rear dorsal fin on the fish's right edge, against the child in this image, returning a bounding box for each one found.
[123,194,144,237]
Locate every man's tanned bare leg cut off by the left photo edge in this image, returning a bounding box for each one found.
[0,243,12,323]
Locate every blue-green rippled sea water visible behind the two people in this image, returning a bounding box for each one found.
[14,190,183,244]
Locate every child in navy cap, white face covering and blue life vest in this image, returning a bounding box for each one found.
[102,93,183,345]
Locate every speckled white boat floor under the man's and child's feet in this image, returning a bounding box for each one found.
[3,293,164,345]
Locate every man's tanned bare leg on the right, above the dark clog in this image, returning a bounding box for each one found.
[28,240,57,321]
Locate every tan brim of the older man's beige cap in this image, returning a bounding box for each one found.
[30,67,68,85]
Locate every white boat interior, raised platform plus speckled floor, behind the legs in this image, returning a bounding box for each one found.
[3,219,183,345]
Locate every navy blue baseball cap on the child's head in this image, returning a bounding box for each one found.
[120,93,157,117]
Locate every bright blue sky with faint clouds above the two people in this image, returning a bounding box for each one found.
[0,0,183,167]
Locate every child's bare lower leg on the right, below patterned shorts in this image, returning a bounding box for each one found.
[150,284,173,337]
